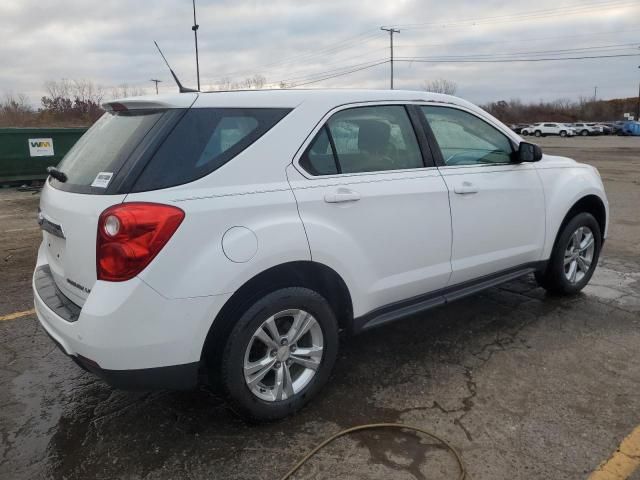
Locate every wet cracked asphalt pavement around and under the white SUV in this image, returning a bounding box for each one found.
[0,139,640,480]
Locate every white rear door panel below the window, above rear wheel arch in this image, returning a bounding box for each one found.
[287,166,451,316]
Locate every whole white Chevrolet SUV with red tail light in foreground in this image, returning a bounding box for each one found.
[33,90,608,420]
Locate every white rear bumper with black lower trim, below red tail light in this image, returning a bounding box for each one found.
[32,244,228,390]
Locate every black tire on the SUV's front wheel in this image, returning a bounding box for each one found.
[536,212,602,295]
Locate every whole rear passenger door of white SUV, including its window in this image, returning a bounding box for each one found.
[287,104,451,316]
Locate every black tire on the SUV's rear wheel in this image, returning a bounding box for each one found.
[220,287,339,422]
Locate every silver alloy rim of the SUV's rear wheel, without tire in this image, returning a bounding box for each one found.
[244,309,324,402]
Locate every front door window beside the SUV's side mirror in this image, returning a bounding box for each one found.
[421,107,513,165]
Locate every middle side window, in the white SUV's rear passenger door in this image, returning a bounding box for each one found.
[300,105,424,175]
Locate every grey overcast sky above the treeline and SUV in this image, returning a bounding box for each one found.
[0,0,640,103]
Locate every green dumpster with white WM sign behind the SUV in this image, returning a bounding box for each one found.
[0,128,87,184]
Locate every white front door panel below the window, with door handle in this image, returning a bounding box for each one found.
[440,164,545,285]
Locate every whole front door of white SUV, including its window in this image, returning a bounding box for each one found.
[420,105,545,285]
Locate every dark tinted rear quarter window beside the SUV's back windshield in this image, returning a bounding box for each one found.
[132,108,290,192]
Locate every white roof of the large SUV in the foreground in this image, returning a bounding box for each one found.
[104,89,477,110]
